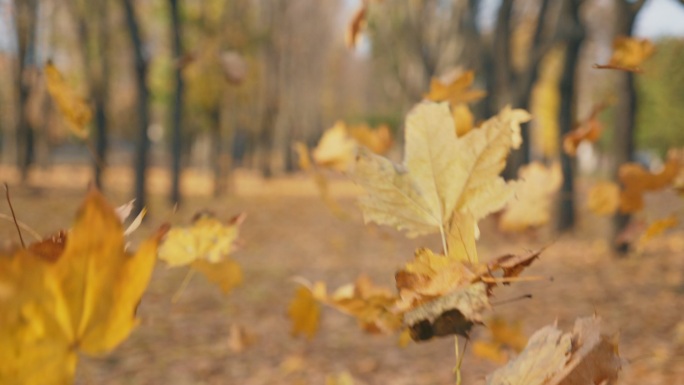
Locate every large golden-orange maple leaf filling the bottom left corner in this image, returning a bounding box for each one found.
[0,190,163,385]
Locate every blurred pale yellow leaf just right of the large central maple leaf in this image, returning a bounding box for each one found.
[499,162,563,231]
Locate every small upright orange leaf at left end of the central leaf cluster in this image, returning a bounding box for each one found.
[287,285,325,339]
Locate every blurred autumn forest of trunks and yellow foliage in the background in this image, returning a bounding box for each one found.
[0,0,684,228]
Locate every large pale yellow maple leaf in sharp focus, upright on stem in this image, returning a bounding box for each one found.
[352,102,529,260]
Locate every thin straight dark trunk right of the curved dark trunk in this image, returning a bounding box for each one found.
[169,0,184,204]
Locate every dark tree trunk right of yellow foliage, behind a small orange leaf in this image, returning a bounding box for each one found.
[557,0,585,232]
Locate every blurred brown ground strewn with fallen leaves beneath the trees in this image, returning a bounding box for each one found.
[0,170,684,385]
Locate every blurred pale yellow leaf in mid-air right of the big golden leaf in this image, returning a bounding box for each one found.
[158,214,246,294]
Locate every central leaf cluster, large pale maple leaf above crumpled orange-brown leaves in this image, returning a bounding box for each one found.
[289,101,539,341]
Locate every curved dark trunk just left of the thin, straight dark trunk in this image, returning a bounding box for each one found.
[122,0,150,213]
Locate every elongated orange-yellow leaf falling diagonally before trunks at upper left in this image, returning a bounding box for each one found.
[43,61,93,139]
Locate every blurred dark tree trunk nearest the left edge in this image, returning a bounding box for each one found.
[15,0,38,182]
